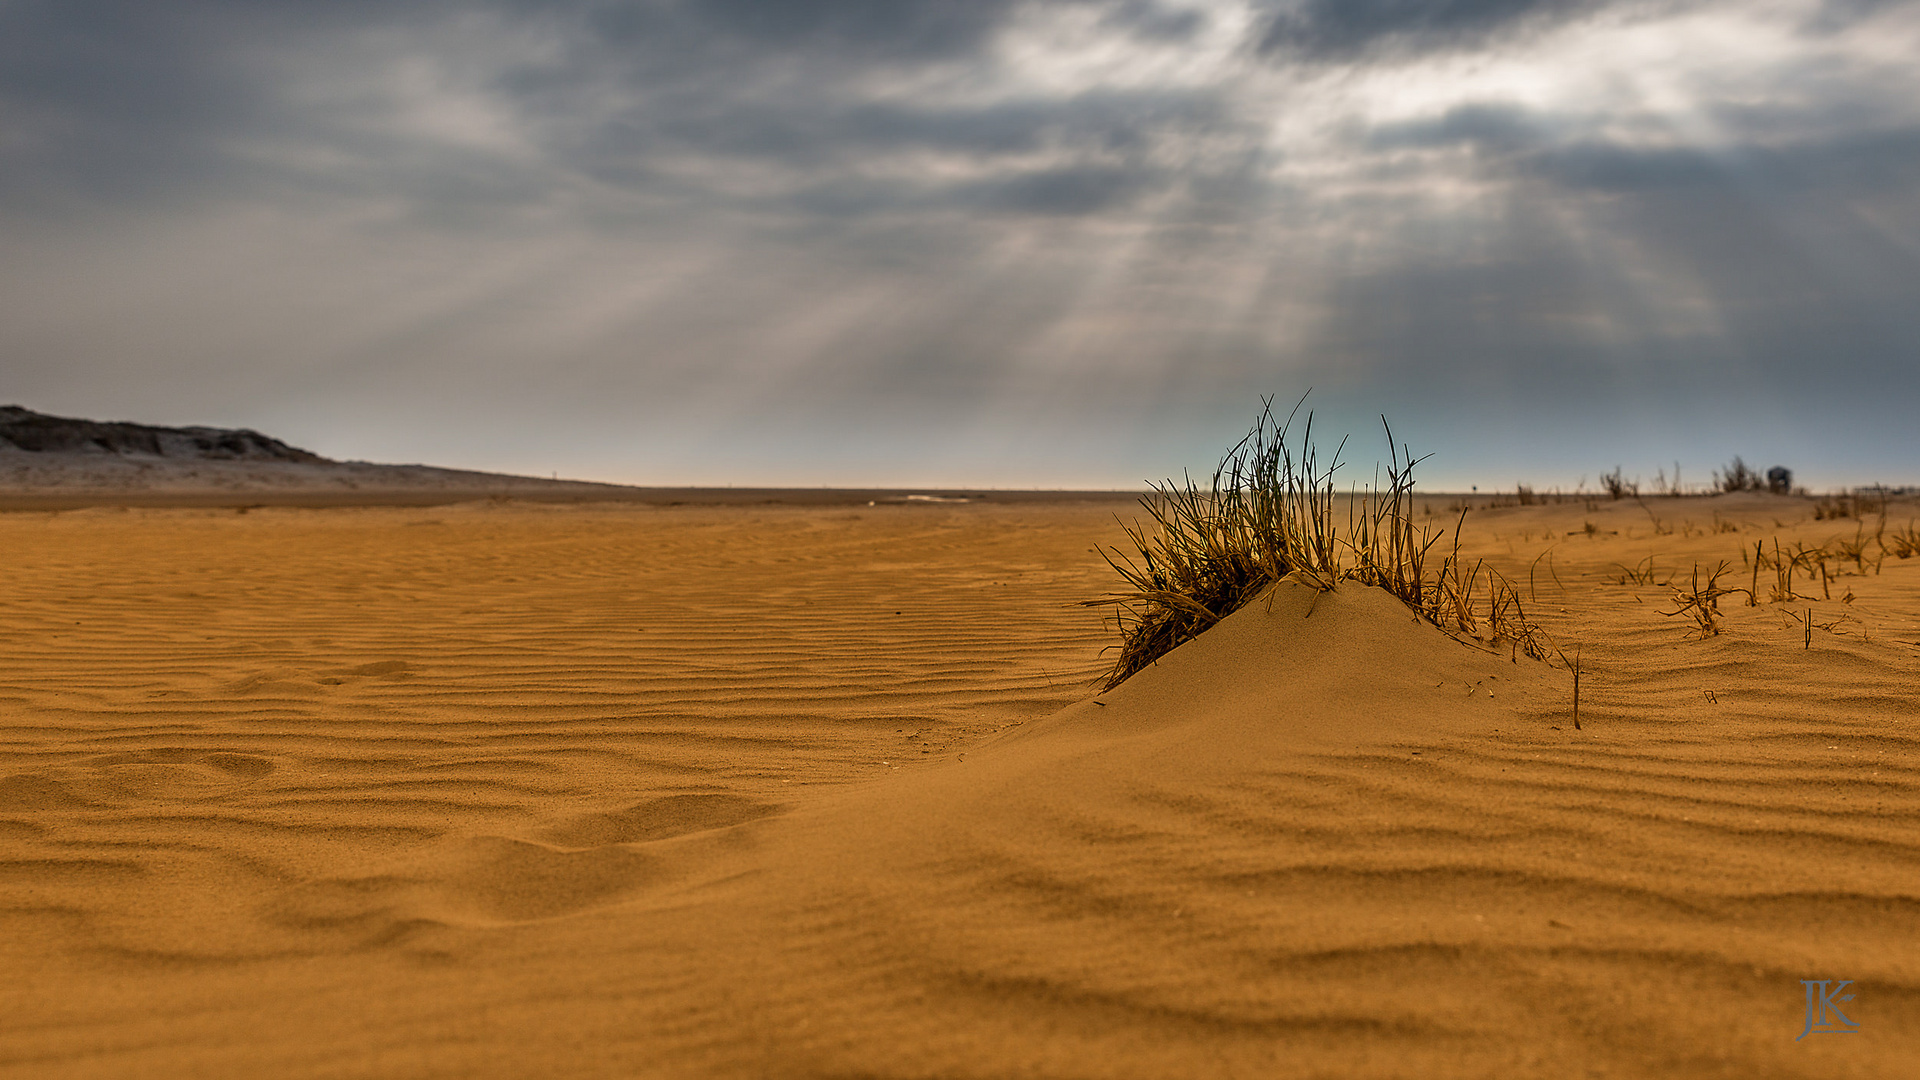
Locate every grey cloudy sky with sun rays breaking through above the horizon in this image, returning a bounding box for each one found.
[0,0,1920,490]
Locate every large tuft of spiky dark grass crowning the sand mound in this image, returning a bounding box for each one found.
[1083,398,1565,690]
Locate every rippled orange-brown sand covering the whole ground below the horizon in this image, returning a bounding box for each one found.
[0,496,1920,1078]
